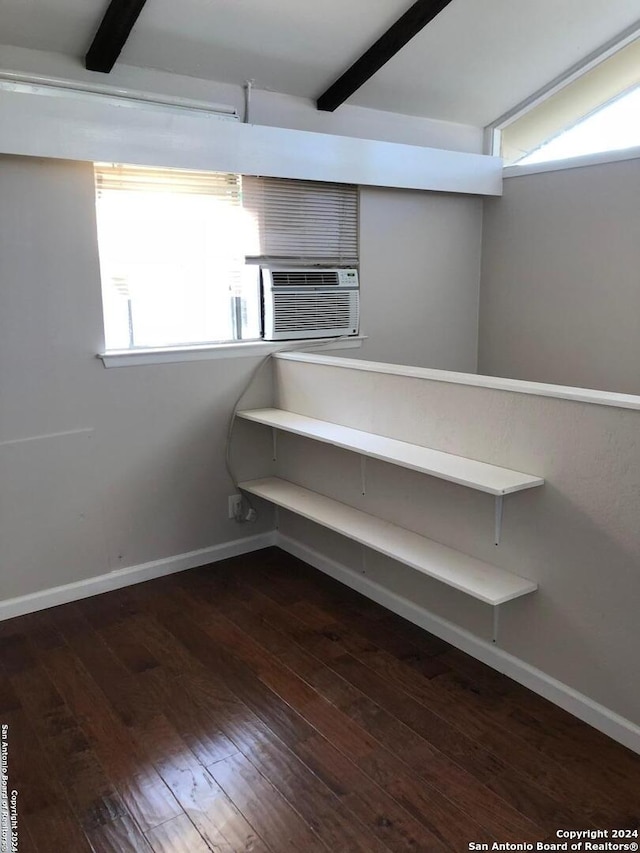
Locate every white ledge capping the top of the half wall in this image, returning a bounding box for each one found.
[274,352,640,410]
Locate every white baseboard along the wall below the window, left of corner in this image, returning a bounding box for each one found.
[0,531,276,622]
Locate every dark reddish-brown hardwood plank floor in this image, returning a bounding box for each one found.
[0,549,640,853]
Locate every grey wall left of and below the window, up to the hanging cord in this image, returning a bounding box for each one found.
[0,157,272,600]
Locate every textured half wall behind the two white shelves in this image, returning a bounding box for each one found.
[272,352,640,732]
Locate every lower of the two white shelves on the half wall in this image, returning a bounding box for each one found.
[240,477,538,606]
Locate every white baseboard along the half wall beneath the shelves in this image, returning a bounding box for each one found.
[275,533,640,754]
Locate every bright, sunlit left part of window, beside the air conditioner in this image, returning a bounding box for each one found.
[96,165,260,350]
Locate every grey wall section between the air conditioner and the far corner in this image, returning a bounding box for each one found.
[358,188,482,372]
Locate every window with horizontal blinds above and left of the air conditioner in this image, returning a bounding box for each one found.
[95,164,357,350]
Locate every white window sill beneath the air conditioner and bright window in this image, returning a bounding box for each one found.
[97,335,366,367]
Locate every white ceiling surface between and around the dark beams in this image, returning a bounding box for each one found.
[0,0,638,126]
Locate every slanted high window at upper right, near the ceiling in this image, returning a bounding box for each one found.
[495,31,640,166]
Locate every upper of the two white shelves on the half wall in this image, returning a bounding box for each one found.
[238,409,544,497]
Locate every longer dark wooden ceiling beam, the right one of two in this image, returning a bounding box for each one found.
[316,0,451,112]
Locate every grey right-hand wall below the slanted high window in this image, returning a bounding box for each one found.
[479,159,640,394]
